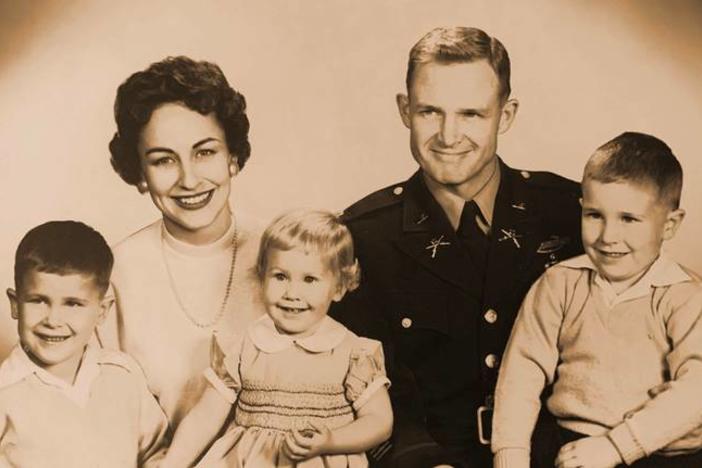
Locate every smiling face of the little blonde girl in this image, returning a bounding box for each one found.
[263,248,346,338]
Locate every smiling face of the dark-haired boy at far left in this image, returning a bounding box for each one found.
[7,270,109,383]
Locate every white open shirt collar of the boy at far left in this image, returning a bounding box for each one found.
[0,345,100,406]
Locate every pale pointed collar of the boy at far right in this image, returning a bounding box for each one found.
[561,252,692,305]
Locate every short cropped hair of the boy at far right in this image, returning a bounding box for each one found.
[583,132,683,210]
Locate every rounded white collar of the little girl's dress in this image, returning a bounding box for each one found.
[249,315,348,353]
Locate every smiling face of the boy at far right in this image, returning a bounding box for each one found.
[582,180,684,293]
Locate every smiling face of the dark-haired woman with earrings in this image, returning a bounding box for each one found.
[137,103,237,244]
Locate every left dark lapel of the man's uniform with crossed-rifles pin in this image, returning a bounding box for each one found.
[396,172,483,298]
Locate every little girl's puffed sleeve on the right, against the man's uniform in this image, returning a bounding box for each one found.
[344,338,390,410]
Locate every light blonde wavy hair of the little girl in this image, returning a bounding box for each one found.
[256,210,361,291]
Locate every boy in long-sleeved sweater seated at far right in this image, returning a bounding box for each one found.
[492,133,702,468]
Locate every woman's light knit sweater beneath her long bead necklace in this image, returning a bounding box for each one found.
[98,214,264,427]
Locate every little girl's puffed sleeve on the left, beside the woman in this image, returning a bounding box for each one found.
[204,335,243,404]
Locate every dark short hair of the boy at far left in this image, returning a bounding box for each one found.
[15,221,114,295]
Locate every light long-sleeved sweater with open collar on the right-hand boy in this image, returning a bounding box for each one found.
[492,255,702,468]
